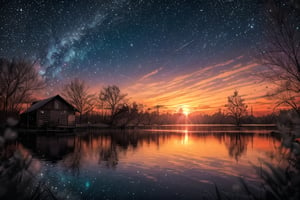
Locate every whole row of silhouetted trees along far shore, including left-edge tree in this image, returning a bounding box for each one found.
[0,59,284,127]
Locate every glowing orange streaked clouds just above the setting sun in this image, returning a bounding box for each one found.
[125,57,274,115]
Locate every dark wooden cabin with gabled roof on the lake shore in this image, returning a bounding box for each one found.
[21,95,78,127]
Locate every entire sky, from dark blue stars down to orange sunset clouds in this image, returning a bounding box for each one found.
[0,0,288,113]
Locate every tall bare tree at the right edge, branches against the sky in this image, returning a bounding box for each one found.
[258,0,300,116]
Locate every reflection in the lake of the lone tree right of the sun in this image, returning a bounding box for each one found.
[225,133,249,161]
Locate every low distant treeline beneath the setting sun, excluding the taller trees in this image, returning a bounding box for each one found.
[78,108,278,127]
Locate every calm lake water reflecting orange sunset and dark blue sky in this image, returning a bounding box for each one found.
[19,125,279,199]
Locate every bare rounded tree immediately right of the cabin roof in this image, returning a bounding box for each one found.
[63,78,95,123]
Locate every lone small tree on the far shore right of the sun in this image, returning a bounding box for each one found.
[225,90,248,126]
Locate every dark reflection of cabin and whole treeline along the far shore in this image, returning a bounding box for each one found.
[22,127,284,171]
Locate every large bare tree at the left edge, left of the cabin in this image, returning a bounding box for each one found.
[0,59,45,118]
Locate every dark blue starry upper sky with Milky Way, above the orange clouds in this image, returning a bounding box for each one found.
[0,0,278,112]
